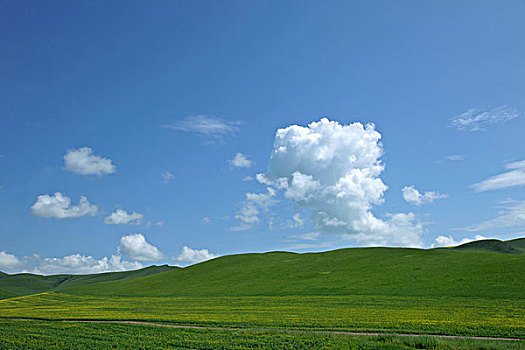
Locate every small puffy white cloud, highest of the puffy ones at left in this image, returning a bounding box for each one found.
[64,147,117,176]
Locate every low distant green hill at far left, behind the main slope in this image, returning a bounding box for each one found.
[0,265,176,299]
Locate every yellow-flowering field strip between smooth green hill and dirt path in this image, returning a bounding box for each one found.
[0,293,525,338]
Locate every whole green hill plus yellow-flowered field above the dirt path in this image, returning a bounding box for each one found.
[0,240,525,349]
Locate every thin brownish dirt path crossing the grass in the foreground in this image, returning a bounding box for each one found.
[12,318,524,341]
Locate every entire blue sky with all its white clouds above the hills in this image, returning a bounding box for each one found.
[0,0,525,273]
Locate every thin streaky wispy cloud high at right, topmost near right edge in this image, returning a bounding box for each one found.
[449,106,520,131]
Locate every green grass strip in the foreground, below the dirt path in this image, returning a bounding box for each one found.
[0,321,523,350]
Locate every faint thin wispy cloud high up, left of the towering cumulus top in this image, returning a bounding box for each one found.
[162,114,243,139]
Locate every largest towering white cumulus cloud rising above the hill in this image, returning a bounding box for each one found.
[237,118,423,246]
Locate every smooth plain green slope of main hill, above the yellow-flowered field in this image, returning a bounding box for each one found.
[64,248,525,298]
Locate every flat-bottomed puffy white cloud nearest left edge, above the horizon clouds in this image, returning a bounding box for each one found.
[31,192,98,219]
